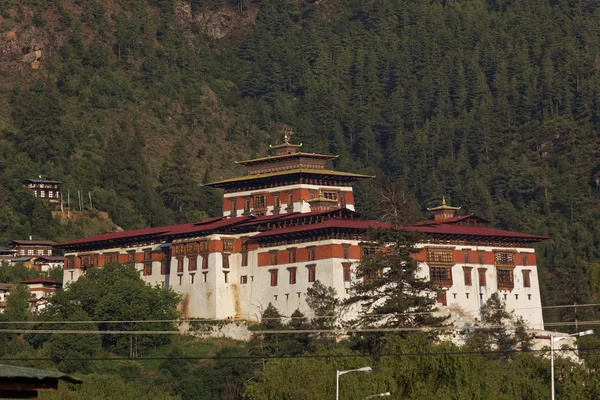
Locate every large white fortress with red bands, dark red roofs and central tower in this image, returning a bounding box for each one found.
[56,136,546,329]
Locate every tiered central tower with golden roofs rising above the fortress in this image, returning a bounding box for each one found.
[207,133,372,217]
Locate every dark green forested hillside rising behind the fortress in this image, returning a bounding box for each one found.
[0,0,600,320]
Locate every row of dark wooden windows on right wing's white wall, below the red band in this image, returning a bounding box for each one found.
[429,266,531,289]
